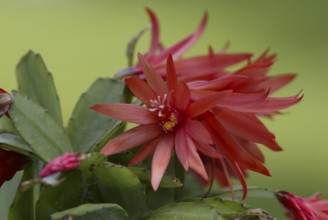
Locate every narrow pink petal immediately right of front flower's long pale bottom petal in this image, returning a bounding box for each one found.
[175,128,189,171]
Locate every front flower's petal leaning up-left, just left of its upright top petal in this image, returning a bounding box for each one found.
[138,53,168,97]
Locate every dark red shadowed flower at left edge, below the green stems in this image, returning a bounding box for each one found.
[0,149,27,187]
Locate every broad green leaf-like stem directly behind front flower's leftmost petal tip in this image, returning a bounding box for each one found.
[66,78,124,152]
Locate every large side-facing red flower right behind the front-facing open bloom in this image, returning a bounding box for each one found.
[187,66,302,199]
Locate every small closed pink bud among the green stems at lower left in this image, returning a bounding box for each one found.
[39,153,81,177]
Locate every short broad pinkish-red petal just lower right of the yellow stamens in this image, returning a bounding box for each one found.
[184,120,213,144]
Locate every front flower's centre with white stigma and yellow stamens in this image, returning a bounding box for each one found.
[149,94,179,133]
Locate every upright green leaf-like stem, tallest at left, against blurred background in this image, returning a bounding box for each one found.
[16,51,63,125]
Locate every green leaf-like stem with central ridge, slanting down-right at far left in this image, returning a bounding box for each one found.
[9,91,72,162]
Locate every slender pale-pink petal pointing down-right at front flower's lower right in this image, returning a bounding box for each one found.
[186,135,208,181]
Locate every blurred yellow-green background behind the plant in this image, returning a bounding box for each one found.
[0,0,328,220]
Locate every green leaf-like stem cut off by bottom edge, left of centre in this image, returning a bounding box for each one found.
[51,204,129,220]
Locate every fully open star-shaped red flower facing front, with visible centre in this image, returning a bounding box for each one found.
[92,55,228,190]
